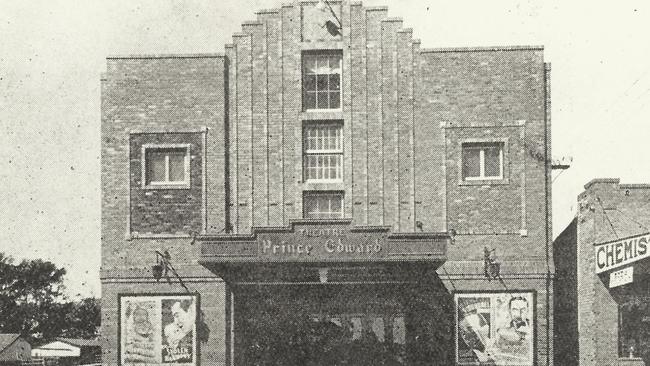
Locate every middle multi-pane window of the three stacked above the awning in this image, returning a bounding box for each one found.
[303,123,343,181]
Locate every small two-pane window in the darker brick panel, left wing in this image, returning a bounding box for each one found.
[143,146,190,186]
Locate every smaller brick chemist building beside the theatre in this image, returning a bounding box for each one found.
[554,178,650,366]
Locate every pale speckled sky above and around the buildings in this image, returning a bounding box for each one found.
[0,0,650,297]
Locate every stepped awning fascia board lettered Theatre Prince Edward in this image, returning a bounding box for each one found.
[199,222,449,262]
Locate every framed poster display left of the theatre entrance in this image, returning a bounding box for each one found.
[119,294,199,366]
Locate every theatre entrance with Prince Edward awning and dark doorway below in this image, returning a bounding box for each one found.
[197,219,454,366]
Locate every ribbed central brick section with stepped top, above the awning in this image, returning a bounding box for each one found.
[226,2,444,232]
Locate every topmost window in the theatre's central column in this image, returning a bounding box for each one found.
[302,52,342,110]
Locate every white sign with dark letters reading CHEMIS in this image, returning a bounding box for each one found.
[594,233,650,273]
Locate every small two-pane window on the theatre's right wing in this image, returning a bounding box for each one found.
[462,142,503,180]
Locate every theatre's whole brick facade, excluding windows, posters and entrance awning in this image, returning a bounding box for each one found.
[102,1,554,365]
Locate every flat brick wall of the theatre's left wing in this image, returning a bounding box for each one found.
[101,55,226,365]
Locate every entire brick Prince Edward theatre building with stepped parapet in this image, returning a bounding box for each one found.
[101,0,554,366]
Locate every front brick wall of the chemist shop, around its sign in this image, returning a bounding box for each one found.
[576,179,650,366]
